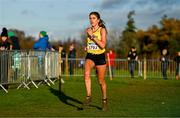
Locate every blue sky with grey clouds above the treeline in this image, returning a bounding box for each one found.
[0,0,180,40]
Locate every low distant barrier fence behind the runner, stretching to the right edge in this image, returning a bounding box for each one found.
[62,58,176,79]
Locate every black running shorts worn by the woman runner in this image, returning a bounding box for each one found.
[86,53,106,66]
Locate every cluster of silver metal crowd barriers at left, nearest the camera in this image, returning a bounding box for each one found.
[0,51,60,92]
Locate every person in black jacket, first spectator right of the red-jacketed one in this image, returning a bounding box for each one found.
[127,47,138,78]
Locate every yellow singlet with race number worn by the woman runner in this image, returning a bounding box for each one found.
[87,27,105,54]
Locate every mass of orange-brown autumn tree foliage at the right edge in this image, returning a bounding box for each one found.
[137,15,180,58]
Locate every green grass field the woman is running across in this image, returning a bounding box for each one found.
[0,77,180,117]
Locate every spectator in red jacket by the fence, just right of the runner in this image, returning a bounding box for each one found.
[107,49,116,77]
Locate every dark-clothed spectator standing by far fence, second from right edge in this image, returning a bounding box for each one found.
[160,49,168,80]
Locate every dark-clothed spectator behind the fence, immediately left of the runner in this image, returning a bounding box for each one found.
[68,43,76,75]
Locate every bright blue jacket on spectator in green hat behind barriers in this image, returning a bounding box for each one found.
[33,35,51,51]
